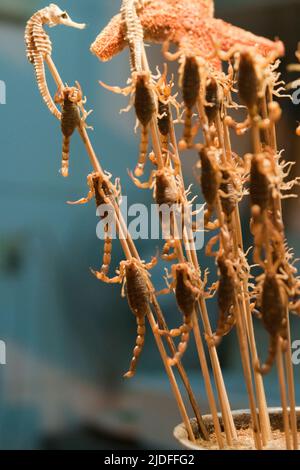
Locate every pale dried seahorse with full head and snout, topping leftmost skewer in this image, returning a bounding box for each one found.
[25,3,85,119]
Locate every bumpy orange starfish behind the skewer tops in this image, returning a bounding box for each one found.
[91,0,284,65]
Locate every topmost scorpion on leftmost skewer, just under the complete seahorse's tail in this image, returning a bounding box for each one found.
[54,82,92,177]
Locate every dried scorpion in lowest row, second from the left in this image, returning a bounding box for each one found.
[158,262,207,366]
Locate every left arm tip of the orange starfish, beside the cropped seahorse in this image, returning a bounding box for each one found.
[91,14,127,62]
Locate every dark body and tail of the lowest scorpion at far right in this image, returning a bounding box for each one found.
[256,273,287,374]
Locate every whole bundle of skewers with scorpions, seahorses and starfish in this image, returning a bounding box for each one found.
[26,0,300,449]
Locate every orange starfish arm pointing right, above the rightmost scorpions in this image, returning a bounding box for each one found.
[205,19,284,56]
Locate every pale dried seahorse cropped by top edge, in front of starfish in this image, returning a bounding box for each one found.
[121,0,144,72]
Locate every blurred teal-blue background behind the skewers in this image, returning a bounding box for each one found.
[0,0,300,449]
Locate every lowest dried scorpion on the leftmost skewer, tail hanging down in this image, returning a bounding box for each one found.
[92,258,157,379]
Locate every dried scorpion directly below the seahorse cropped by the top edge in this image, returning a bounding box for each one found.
[100,71,157,176]
